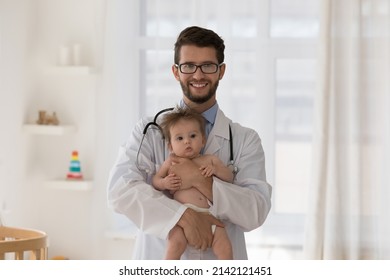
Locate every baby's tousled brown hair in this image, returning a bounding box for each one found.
[160,107,206,143]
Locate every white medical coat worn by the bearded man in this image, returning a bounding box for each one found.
[108,109,271,259]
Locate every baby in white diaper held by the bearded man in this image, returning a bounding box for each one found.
[153,108,234,260]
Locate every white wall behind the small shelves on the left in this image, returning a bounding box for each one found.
[0,0,131,259]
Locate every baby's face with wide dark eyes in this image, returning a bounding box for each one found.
[170,120,205,158]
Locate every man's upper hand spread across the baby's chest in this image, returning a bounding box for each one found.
[169,155,213,202]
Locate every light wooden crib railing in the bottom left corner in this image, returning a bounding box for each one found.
[0,226,48,260]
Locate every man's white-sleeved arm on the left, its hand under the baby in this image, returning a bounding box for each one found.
[107,121,186,239]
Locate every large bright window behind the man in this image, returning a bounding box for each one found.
[135,0,319,257]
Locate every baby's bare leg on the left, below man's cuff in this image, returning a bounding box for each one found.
[165,226,187,260]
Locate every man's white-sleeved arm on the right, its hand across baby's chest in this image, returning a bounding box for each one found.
[206,128,272,231]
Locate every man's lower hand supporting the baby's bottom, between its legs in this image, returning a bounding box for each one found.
[177,208,224,251]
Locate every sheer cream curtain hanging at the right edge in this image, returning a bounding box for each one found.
[305,0,390,259]
